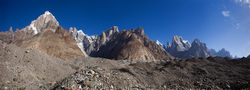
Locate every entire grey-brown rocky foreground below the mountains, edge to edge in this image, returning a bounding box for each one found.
[0,42,250,90]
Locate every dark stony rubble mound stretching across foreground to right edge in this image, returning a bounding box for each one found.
[47,57,250,90]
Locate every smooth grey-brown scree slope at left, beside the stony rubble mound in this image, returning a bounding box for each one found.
[0,41,75,90]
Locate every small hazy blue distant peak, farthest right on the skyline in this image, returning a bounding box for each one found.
[210,48,232,58]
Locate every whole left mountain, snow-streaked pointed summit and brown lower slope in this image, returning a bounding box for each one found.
[0,11,86,60]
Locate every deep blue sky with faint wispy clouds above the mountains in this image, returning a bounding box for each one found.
[0,0,250,56]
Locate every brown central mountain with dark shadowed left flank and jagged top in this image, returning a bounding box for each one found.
[96,27,172,61]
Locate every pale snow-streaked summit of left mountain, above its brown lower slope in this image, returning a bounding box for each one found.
[0,11,59,43]
